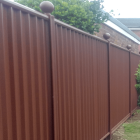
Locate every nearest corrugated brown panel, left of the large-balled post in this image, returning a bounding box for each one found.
[0,3,53,140]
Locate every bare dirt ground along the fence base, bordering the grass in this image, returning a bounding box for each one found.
[111,109,140,140]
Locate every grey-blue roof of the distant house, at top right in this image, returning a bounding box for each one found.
[117,18,140,28]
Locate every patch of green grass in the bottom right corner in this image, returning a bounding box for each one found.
[123,121,140,140]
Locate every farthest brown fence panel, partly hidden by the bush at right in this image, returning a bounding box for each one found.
[131,53,140,111]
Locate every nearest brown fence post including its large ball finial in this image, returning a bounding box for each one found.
[40,1,59,140]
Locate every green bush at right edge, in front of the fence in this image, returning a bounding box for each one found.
[135,64,140,107]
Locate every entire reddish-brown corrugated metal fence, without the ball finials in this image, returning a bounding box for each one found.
[0,1,140,140]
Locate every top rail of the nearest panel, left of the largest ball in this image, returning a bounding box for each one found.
[0,0,49,20]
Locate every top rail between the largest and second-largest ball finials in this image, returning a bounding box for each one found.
[55,19,108,43]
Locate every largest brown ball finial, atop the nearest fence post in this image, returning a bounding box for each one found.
[40,1,54,13]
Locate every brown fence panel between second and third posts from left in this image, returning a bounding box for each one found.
[110,46,129,131]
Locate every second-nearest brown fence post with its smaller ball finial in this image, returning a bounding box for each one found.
[103,33,112,140]
